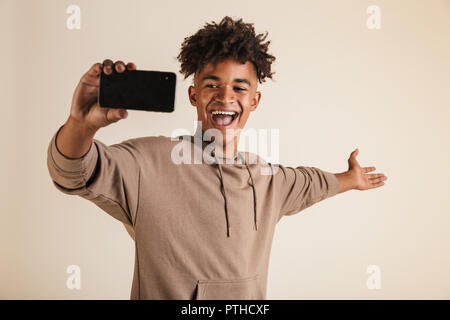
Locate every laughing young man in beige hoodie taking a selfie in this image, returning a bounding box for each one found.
[47,17,386,299]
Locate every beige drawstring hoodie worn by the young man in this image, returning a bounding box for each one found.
[47,126,338,299]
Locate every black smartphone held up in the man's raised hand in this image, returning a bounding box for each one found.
[98,70,176,112]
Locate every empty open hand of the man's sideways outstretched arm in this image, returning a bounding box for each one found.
[334,149,387,193]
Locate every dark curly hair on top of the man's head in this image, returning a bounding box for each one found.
[177,16,275,83]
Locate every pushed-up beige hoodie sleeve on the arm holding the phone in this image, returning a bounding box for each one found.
[47,126,141,226]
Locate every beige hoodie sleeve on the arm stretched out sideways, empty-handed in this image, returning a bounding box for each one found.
[276,165,339,220]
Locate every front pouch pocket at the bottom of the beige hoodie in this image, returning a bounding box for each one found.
[195,275,262,300]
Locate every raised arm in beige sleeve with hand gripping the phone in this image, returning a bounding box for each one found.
[47,60,143,226]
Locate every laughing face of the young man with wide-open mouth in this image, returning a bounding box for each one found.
[189,59,261,143]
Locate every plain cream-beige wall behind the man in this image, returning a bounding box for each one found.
[0,0,450,299]
